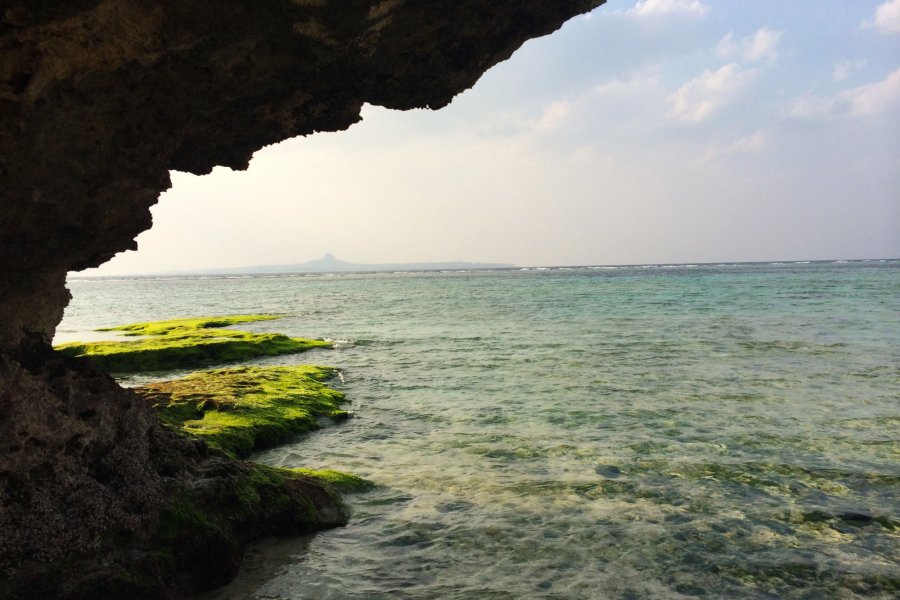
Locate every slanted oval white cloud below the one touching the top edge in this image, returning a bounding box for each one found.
[669,63,756,123]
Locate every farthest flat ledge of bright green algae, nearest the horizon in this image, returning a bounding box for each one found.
[56,314,332,373]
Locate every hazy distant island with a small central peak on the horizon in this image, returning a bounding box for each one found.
[178,254,515,275]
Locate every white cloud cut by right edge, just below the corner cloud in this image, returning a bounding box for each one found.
[787,69,900,119]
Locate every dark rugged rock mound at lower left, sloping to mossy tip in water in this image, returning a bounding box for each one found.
[0,350,356,600]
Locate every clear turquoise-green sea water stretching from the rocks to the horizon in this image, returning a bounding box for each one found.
[57,261,900,600]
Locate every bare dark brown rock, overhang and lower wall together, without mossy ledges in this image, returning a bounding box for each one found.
[0,0,602,597]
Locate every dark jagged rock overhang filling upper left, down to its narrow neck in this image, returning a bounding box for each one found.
[0,0,603,347]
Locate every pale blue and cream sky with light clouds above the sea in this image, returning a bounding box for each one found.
[85,0,900,275]
